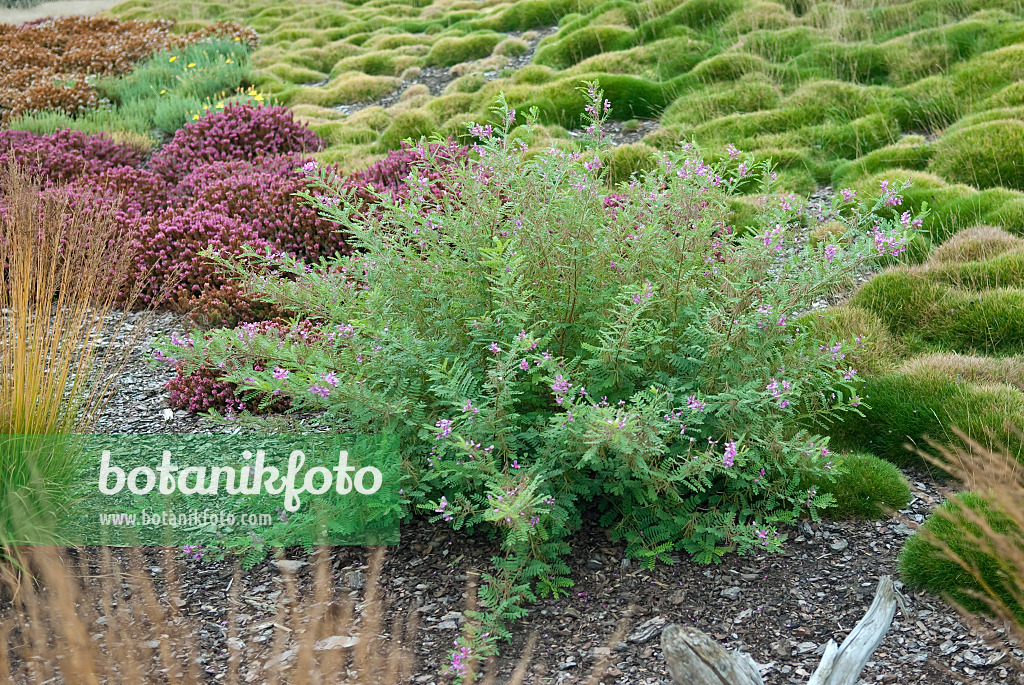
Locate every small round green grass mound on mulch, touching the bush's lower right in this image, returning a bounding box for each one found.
[811,454,910,519]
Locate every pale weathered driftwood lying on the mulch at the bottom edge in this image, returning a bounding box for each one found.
[662,575,906,685]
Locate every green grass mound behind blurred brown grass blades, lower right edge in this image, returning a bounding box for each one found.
[898,493,1024,623]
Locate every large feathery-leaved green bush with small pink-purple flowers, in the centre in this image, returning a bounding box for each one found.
[161,84,914,673]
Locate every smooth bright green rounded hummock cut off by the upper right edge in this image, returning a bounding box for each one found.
[931,120,1024,190]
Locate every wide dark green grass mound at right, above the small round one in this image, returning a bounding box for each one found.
[829,369,1024,466]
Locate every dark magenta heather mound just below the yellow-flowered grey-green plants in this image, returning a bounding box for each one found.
[150,102,322,182]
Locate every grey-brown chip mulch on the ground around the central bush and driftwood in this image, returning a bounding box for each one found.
[70,313,1024,685]
